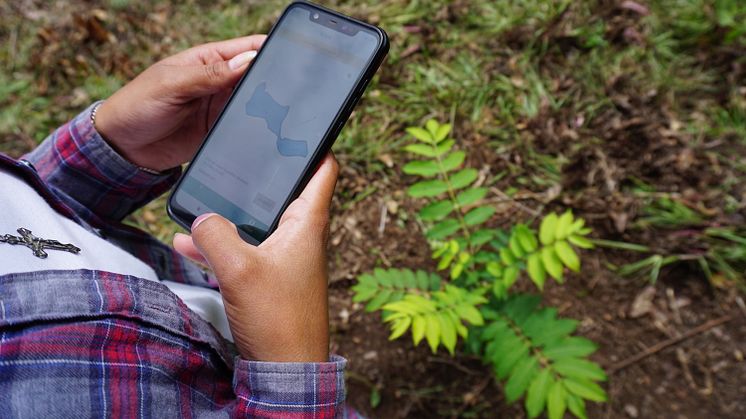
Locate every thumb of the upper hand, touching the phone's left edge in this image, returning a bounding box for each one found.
[172,51,257,98]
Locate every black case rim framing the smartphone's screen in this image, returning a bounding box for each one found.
[166,1,389,245]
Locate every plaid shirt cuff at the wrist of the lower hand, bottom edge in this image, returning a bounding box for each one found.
[233,355,347,418]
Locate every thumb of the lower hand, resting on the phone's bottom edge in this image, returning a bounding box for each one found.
[192,213,255,276]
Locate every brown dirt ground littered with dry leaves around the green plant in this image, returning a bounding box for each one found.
[0,0,746,419]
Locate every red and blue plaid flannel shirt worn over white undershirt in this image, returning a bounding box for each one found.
[0,103,356,418]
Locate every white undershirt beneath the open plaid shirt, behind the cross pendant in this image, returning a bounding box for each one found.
[0,170,232,340]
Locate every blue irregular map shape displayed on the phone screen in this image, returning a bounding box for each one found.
[246,82,308,157]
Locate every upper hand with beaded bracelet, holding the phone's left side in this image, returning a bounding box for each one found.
[96,35,266,171]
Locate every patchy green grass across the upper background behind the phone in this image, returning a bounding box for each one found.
[0,0,746,286]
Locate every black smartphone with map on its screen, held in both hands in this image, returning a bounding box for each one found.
[167,2,389,244]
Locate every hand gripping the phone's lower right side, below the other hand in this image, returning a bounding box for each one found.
[174,155,339,362]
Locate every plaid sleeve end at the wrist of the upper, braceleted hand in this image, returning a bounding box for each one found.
[23,104,181,221]
